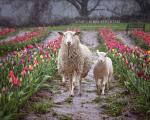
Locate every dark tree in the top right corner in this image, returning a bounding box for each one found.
[135,0,150,14]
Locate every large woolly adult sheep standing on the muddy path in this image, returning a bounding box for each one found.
[57,31,92,96]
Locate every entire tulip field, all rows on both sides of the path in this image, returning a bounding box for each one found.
[0,27,150,120]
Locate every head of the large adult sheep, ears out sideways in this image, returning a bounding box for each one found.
[58,31,80,47]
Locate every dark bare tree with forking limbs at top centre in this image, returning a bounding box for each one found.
[66,0,101,17]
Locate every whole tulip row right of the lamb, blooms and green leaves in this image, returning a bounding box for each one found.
[99,29,150,113]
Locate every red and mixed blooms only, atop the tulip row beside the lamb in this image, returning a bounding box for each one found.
[100,29,150,80]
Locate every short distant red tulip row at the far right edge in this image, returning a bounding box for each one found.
[130,30,150,50]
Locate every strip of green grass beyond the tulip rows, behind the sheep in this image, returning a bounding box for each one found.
[48,23,150,31]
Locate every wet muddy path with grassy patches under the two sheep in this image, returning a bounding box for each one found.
[22,31,140,120]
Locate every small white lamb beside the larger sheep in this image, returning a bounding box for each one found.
[93,50,113,95]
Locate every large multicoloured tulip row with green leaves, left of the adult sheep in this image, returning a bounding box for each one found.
[0,37,61,119]
